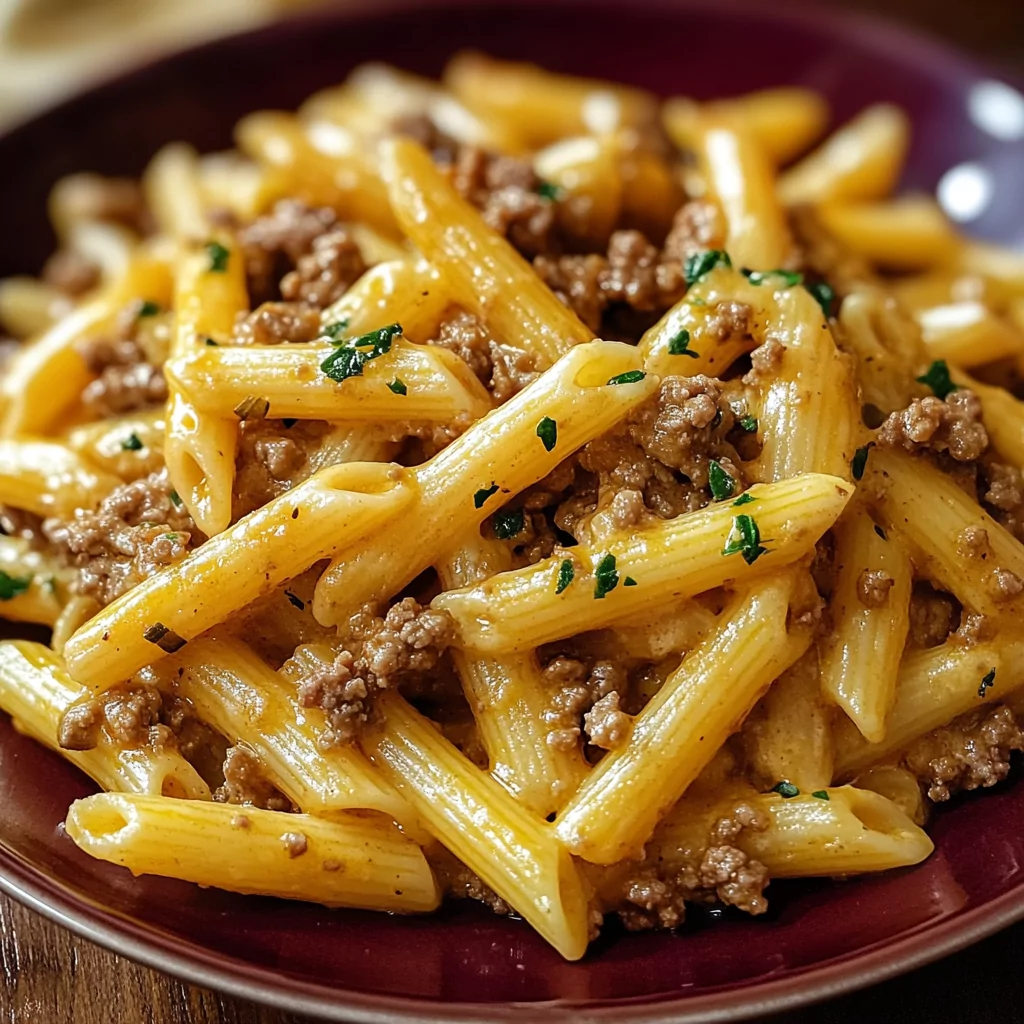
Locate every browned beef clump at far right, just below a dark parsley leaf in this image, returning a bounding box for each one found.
[878,389,988,462]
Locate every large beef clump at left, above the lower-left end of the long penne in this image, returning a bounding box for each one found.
[43,471,195,604]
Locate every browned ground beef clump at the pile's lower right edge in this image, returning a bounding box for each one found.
[904,706,1024,802]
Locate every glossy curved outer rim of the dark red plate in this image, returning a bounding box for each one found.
[0,0,1024,1024]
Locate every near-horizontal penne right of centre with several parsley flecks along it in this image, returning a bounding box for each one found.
[433,474,853,652]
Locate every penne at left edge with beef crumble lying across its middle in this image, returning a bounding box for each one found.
[0,640,210,800]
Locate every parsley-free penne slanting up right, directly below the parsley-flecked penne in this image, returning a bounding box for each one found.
[556,577,811,864]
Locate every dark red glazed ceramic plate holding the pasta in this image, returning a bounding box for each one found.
[0,0,1024,1021]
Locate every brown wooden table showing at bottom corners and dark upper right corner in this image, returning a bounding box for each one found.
[0,0,1024,1024]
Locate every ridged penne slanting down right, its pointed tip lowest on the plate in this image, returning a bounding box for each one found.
[362,692,588,959]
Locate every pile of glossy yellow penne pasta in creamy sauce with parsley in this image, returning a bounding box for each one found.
[0,54,1024,959]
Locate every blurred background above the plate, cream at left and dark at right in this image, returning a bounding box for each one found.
[0,0,1024,130]
